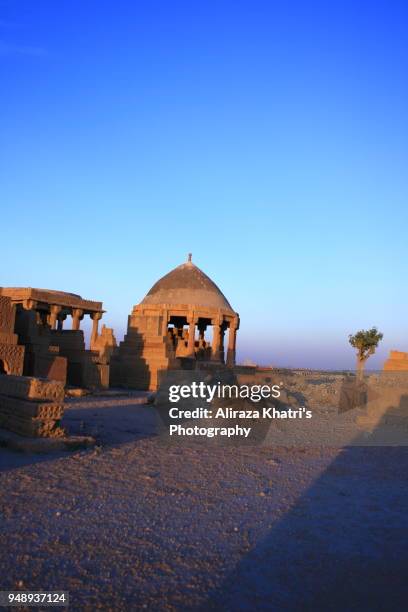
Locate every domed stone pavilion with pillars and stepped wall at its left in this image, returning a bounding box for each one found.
[110,255,239,390]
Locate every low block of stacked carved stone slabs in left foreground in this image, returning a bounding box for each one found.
[0,375,64,437]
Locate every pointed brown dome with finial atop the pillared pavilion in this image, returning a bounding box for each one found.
[142,259,235,314]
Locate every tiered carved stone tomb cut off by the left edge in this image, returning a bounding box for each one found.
[0,296,24,376]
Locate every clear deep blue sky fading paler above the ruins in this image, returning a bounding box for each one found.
[0,0,408,368]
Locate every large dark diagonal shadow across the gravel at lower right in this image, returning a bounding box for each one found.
[206,407,408,612]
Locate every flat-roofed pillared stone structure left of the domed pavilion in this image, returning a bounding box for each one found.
[0,287,109,387]
